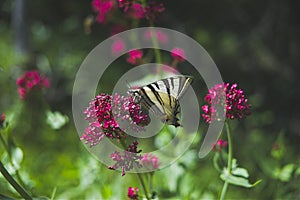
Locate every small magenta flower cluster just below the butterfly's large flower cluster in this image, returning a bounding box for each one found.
[108,141,142,176]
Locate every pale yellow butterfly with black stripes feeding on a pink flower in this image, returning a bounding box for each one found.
[129,76,192,127]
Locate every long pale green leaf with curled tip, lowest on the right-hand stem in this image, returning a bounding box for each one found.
[220,169,261,188]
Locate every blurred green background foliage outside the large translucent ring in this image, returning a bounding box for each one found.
[0,0,300,199]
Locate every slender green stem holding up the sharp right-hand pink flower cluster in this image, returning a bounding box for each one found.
[220,120,233,200]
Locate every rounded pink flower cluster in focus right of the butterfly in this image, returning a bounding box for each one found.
[202,83,251,123]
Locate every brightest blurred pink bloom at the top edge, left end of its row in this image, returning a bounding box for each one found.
[92,0,115,23]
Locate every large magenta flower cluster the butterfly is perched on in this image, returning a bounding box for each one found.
[80,94,148,147]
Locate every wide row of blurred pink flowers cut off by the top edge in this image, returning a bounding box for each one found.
[92,0,165,23]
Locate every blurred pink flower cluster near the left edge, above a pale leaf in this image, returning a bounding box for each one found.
[17,70,50,100]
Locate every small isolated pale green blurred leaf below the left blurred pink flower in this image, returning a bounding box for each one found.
[47,111,69,130]
